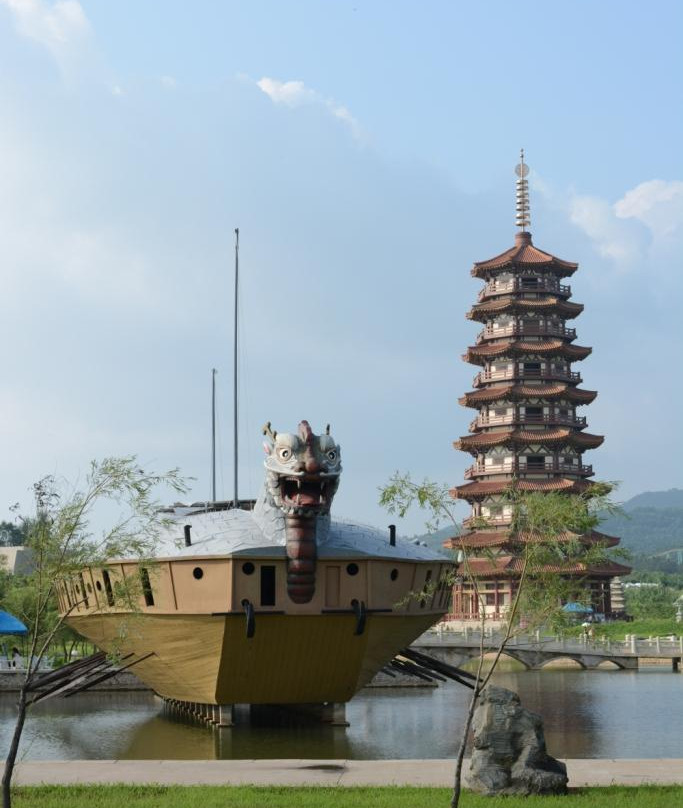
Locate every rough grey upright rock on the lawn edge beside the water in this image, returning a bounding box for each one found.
[466,685,567,796]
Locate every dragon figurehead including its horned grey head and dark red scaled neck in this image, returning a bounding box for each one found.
[263,421,341,603]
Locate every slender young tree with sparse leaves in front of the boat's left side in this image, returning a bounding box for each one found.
[2,456,186,808]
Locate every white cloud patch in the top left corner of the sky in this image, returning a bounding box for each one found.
[0,0,92,72]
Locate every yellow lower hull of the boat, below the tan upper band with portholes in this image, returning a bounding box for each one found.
[68,611,440,704]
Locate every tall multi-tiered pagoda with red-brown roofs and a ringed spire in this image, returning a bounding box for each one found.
[446,151,630,620]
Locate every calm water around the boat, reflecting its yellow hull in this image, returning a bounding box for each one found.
[0,667,683,760]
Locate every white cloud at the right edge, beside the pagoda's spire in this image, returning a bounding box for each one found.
[569,180,683,269]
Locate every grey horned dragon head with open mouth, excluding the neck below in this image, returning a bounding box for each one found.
[263,421,341,516]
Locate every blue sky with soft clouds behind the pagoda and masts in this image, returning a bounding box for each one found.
[0,0,683,534]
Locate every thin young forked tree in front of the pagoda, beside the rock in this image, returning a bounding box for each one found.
[380,472,617,808]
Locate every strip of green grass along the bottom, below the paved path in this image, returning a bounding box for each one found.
[13,786,683,808]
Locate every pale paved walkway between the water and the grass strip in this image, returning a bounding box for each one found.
[14,759,683,788]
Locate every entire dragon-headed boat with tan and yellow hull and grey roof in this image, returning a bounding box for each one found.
[59,421,452,716]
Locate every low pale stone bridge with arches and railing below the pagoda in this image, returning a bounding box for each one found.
[412,629,683,671]
